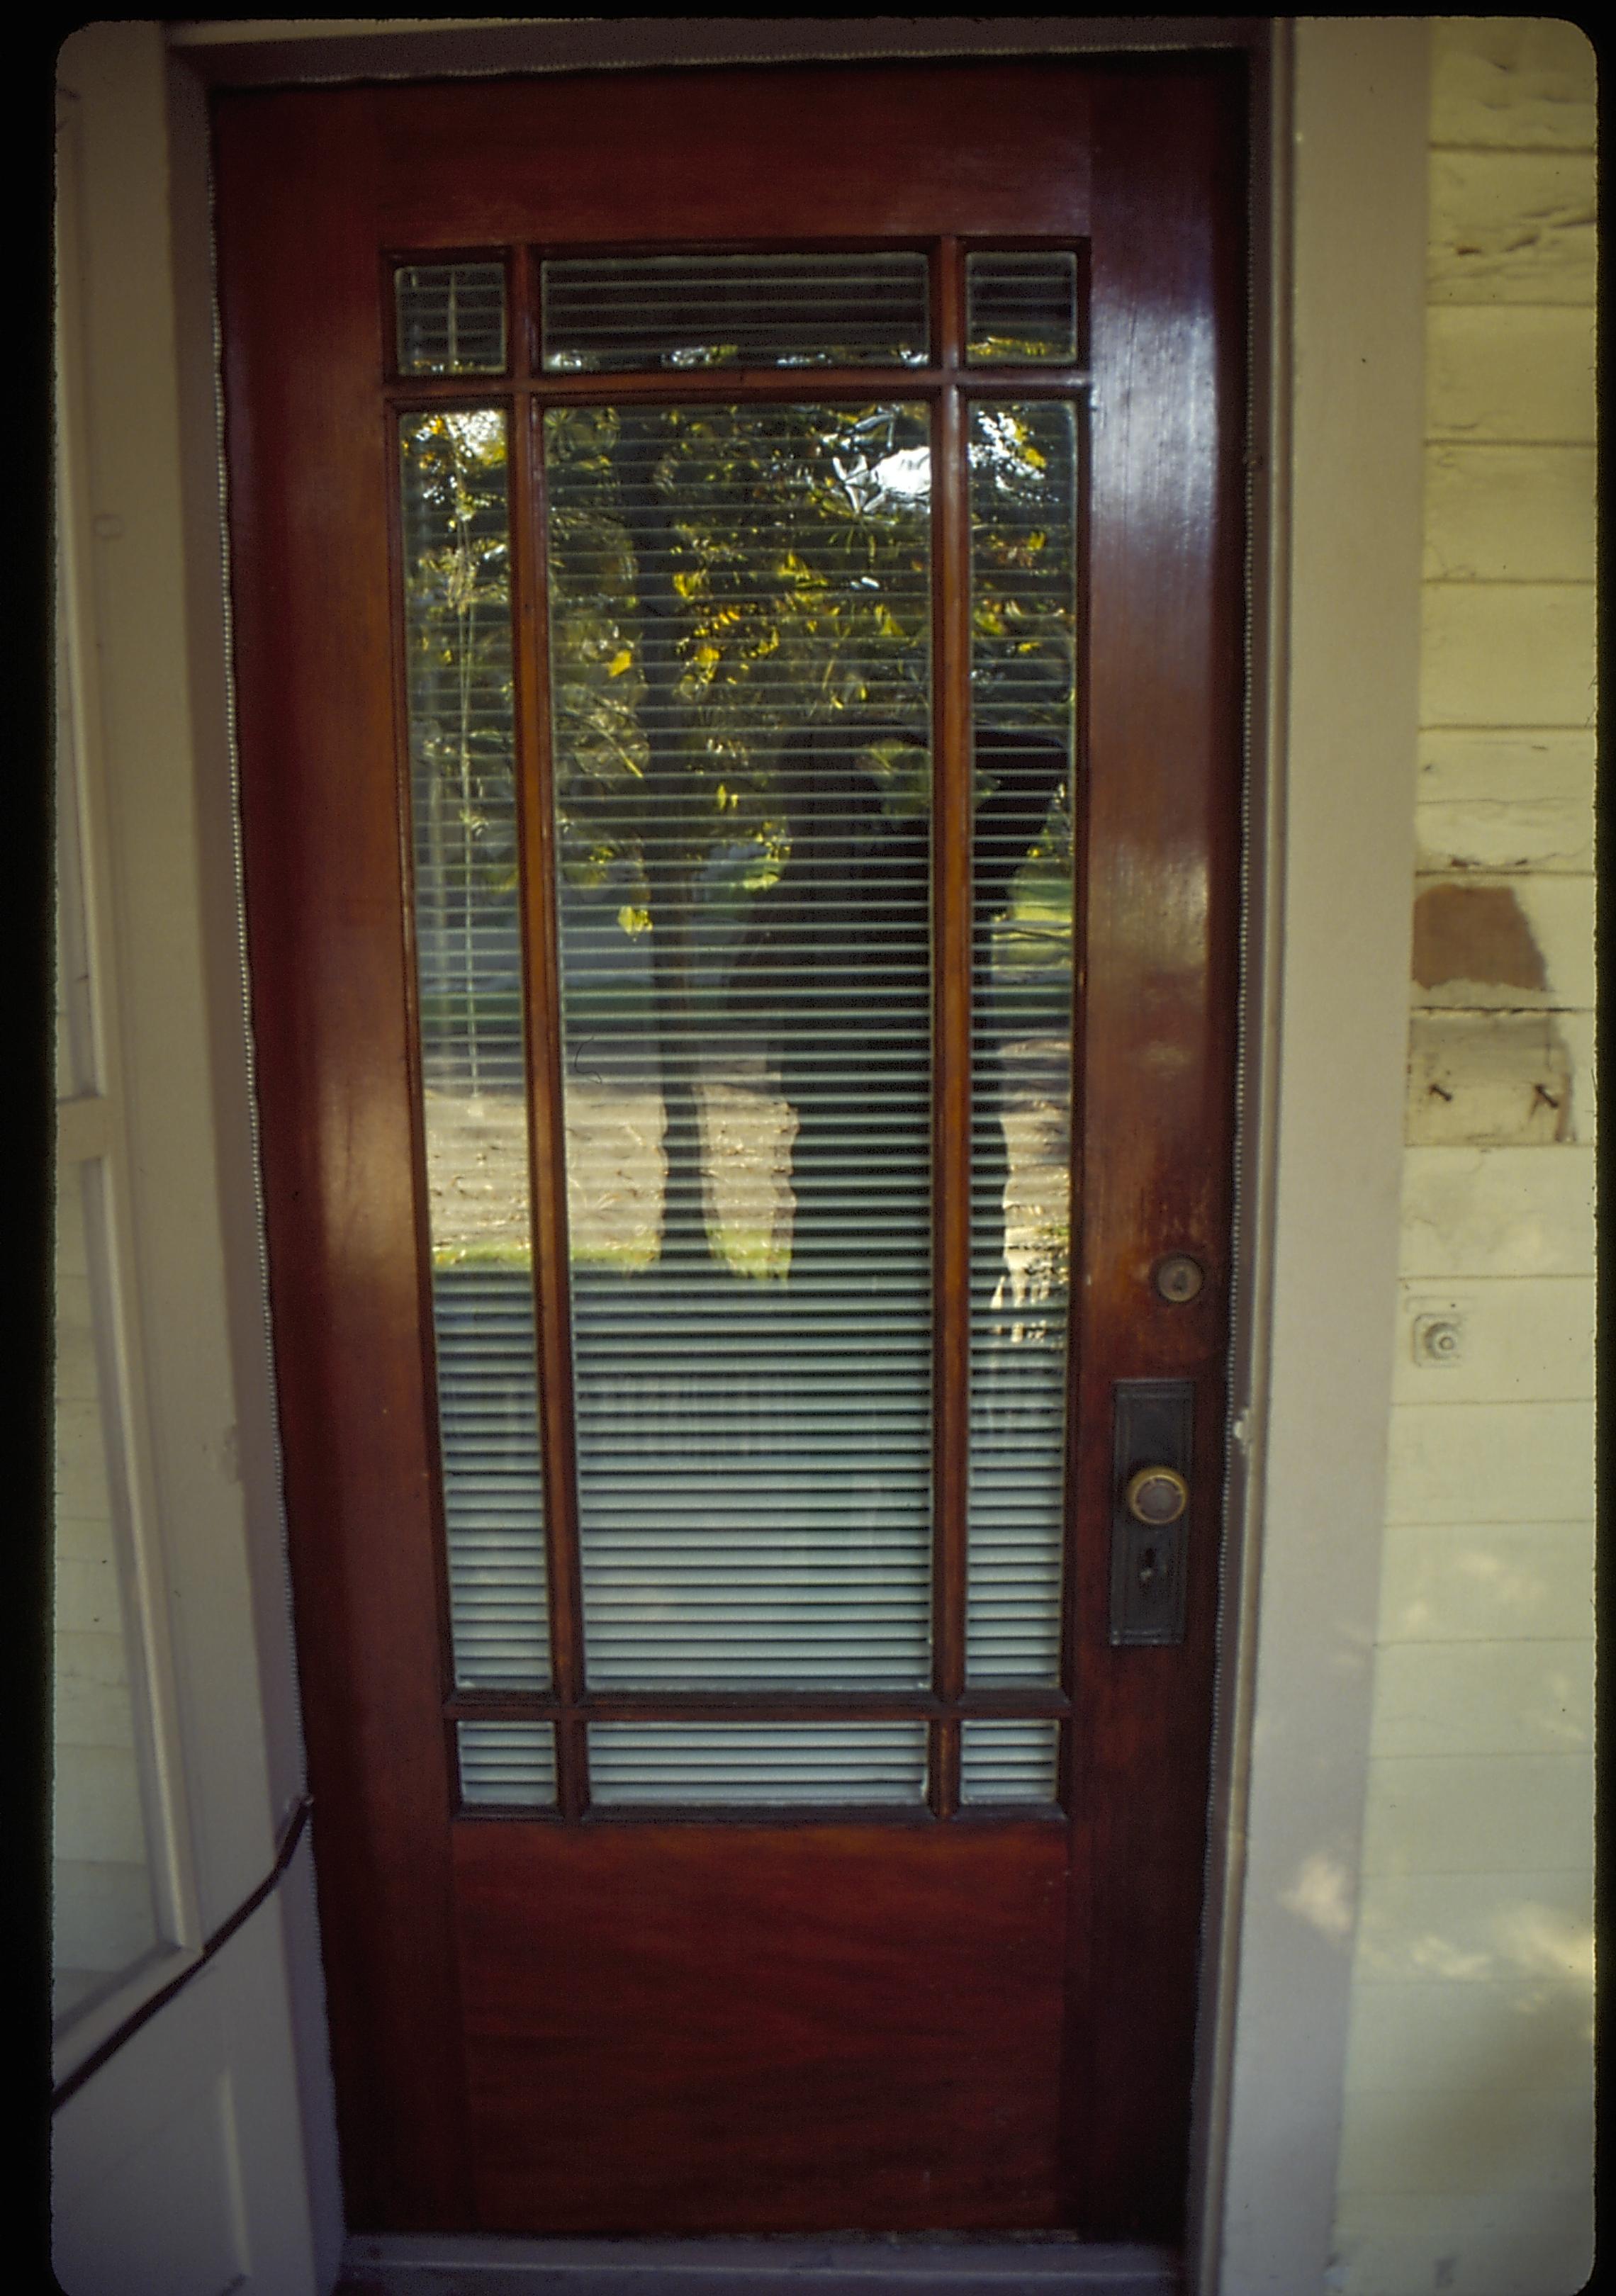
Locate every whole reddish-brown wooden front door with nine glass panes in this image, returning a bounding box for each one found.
[215,60,1244,2239]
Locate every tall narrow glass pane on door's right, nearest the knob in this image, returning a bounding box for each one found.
[966,402,1077,1683]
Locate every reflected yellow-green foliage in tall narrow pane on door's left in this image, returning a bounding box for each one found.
[400,411,521,1093]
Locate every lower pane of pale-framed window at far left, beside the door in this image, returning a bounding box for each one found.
[50,1161,158,2025]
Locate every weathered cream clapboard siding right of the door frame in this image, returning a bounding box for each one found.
[1334,18,1595,2296]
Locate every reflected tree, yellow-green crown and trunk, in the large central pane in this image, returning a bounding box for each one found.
[546,406,930,1261]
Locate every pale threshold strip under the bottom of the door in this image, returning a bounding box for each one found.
[335,2234,1184,2296]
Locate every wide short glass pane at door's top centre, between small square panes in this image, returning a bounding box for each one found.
[539,255,927,372]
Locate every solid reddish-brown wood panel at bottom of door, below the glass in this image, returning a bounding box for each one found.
[454,1821,1067,2234]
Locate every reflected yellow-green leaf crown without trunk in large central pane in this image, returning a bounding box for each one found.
[546,406,930,889]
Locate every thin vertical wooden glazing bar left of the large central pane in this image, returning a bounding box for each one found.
[512,386,588,1818]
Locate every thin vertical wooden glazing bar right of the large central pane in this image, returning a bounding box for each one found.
[930,237,971,1818]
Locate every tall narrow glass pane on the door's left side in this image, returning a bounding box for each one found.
[400,411,549,1687]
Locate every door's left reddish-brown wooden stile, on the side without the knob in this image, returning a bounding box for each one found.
[215,92,473,2232]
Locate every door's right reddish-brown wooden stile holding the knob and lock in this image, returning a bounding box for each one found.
[1067,57,1244,2239]
